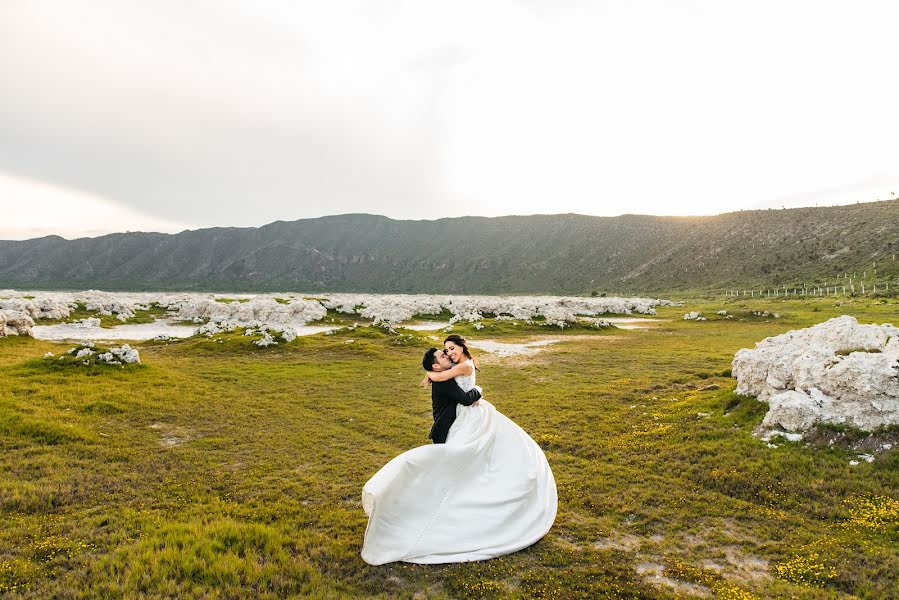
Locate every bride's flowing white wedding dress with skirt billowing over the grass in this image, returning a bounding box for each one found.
[362,360,558,565]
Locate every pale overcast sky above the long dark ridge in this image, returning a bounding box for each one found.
[0,0,899,239]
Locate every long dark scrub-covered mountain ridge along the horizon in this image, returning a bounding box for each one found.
[0,200,899,294]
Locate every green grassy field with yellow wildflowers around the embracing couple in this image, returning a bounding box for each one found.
[0,300,899,598]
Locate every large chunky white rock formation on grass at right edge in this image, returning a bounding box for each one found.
[732,316,899,432]
